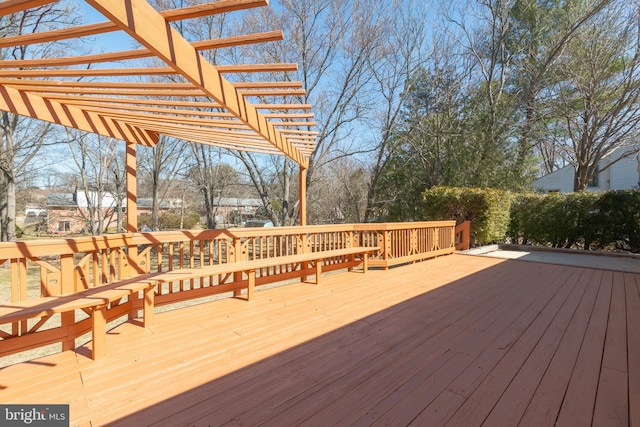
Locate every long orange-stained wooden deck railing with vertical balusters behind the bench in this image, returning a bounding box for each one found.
[0,221,455,305]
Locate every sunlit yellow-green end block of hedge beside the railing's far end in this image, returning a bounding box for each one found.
[423,187,513,245]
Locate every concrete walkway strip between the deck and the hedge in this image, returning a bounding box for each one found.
[459,245,640,273]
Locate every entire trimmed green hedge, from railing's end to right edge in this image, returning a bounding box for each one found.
[424,187,640,253]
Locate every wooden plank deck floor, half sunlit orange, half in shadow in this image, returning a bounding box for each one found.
[0,255,640,427]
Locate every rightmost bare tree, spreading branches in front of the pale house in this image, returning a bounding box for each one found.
[555,2,640,191]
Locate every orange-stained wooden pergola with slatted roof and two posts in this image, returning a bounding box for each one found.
[0,0,317,227]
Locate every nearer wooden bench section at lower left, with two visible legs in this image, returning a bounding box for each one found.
[0,278,155,359]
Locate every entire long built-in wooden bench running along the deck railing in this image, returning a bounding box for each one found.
[0,247,379,359]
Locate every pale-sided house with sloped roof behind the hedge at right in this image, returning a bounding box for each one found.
[533,149,640,193]
